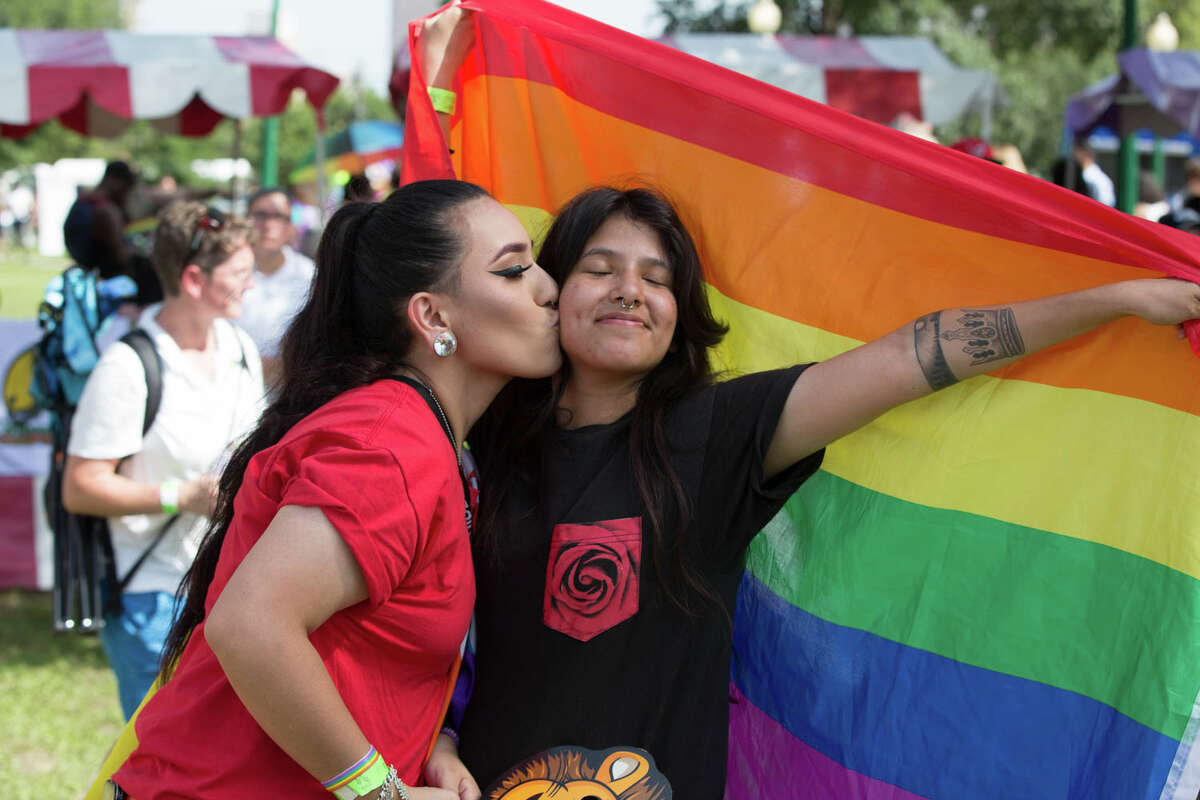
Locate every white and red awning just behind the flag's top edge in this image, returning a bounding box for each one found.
[659,34,1001,125]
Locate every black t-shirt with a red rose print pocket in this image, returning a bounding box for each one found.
[460,366,823,800]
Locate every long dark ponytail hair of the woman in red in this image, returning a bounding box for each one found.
[161,181,487,678]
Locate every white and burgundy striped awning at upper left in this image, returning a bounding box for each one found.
[0,29,338,138]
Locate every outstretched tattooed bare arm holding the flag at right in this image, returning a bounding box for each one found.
[763,278,1200,477]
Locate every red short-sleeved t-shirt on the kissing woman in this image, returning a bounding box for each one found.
[115,380,475,800]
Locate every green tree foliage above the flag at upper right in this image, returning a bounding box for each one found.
[656,0,1200,174]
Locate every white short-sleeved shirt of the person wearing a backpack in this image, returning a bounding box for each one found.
[67,305,264,594]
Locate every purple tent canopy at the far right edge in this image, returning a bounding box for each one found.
[1064,48,1200,137]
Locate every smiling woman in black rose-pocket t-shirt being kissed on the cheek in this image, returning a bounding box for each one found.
[451,183,1200,800]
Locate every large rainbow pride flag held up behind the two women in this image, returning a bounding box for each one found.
[406,0,1200,800]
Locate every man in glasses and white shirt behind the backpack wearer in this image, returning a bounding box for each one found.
[238,187,313,387]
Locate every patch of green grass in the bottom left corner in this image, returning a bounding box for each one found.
[0,589,125,800]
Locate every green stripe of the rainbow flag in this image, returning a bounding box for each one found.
[748,470,1200,739]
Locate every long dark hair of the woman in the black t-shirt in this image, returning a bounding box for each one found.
[476,186,728,614]
